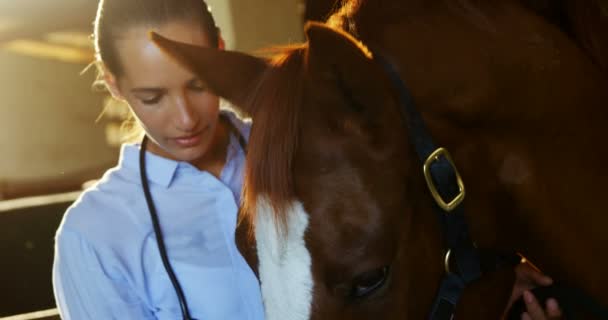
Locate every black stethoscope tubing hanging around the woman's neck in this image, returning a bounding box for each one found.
[139,120,247,320]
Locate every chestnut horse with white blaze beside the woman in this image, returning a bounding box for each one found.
[153,0,608,320]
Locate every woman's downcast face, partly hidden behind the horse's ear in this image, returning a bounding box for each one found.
[106,21,219,162]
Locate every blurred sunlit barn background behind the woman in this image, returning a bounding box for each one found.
[0,0,335,320]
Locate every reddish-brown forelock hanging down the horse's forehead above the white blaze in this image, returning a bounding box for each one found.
[240,45,305,230]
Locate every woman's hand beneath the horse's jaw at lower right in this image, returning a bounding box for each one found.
[507,262,562,320]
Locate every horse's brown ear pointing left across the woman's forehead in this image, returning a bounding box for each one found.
[150,32,268,113]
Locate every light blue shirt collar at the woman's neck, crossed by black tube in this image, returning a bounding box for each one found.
[118,144,179,188]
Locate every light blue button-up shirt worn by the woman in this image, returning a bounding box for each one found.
[53,113,264,320]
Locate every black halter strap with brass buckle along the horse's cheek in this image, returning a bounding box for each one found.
[373,53,481,320]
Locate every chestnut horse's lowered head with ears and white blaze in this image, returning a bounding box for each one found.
[154,24,441,320]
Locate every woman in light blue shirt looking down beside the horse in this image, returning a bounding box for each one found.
[53,0,564,320]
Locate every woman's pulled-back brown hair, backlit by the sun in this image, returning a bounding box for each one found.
[93,0,219,77]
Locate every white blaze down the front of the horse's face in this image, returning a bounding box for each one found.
[255,197,313,320]
